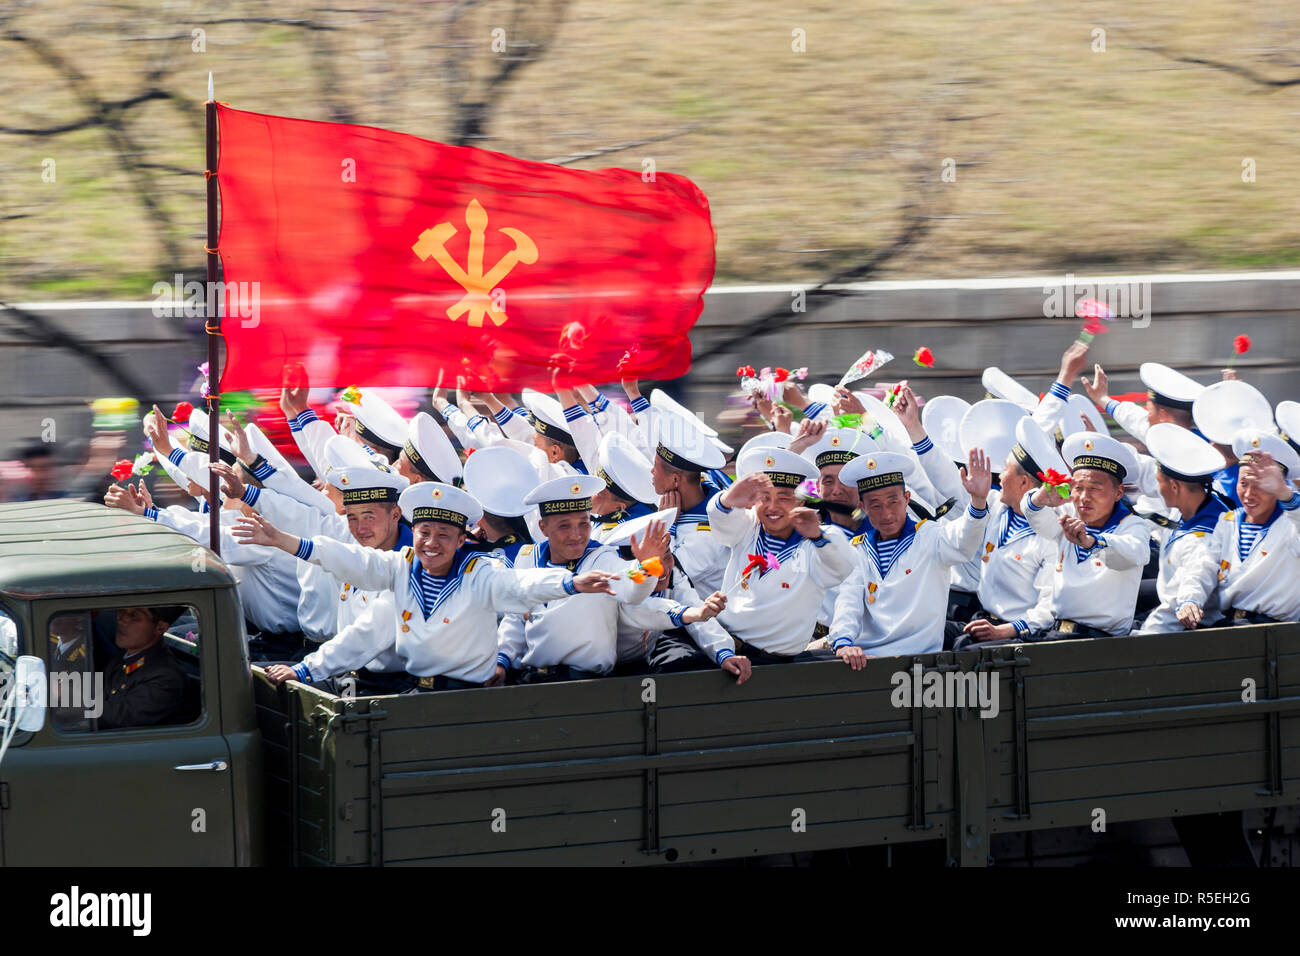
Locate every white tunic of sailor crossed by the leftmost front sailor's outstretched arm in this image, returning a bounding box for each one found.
[497,541,657,674]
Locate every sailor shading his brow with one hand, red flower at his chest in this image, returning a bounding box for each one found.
[707,447,853,665]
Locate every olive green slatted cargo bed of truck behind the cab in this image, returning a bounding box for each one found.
[255,624,1300,866]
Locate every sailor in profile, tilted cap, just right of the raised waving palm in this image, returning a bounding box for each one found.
[954,416,1069,649]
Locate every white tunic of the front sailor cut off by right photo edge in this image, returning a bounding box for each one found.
[1196,494,1300,620]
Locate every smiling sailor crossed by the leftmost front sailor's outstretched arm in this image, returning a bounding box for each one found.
[494,475,667,684]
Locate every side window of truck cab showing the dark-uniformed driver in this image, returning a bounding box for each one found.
[47,606,203,734]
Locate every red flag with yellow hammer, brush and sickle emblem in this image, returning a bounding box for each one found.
[217,105,714,392]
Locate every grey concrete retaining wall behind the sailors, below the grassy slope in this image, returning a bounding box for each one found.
[10,272,1300,458]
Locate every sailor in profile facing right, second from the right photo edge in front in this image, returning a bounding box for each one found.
[1141,421,1229,633]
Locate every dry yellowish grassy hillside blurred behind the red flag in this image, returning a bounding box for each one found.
[0,0,1300,299]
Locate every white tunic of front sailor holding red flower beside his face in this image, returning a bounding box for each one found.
[1023,496,1151,635]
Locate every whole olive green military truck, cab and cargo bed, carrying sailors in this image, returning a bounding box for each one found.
[0,501,1300,866]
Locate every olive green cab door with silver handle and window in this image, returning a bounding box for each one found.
[0,592,235,866]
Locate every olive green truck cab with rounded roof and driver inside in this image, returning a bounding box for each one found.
[0,501,263,866]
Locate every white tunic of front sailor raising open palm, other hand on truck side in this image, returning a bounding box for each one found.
[829,506,988,656]
